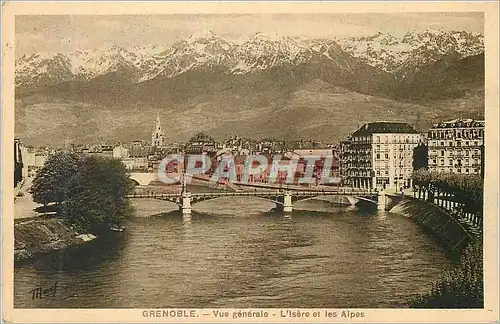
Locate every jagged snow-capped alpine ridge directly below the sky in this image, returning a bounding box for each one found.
[16,30,484,86]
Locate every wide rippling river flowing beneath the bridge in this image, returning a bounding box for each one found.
[14,198,451,308]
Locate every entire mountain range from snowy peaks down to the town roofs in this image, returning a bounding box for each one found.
[15,31,484,145]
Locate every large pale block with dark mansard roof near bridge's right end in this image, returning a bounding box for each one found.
[340,122,421,190]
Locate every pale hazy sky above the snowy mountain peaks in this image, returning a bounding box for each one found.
[15,12,483,57]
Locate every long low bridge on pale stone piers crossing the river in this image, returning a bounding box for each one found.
[127,188,390,214]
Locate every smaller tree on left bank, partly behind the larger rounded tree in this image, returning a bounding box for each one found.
[30,152,82,206]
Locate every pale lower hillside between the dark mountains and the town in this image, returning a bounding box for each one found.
[16,79,440,145]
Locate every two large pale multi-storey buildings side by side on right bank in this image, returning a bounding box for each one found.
[340,119,484,189]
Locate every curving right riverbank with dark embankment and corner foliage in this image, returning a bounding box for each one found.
[391,198,484,308]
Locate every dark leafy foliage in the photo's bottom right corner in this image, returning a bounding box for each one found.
[412,240,484,308]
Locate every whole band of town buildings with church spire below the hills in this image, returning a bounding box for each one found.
[14,114,484,190]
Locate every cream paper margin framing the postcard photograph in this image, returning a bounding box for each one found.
[1,1,499,323]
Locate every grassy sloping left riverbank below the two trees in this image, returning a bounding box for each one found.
[14,218,97,262]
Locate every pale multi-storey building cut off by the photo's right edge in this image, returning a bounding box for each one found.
[427,119,484,174]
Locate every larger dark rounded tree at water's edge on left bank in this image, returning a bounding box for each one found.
[62,157,133,233]
